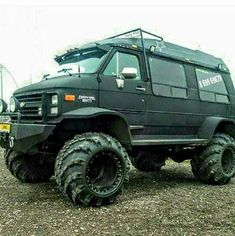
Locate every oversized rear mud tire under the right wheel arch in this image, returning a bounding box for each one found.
[191,133,235,185]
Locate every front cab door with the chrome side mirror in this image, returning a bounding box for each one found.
[99,49,146,125]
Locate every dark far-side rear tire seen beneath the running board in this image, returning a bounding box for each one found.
[130,151,167,172]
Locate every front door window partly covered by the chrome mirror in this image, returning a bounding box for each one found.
[103,52,140,79]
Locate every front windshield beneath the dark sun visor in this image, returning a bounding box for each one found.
[58,48,107,74]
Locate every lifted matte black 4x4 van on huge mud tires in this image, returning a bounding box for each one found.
[0,29,235,206]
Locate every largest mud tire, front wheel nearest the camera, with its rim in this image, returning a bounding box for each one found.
[55,133,129,206]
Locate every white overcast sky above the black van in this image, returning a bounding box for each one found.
[0,1,235,97]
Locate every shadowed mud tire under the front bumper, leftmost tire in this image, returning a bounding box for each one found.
[4,150,54,183]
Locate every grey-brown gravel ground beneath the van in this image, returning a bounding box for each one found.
[0,150,235,236]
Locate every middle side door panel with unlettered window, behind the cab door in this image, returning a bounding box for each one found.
[146,56,196,139]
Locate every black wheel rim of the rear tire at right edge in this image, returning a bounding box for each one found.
[221,148,235,175]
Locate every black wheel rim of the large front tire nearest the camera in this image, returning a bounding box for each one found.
[86,150,123,197]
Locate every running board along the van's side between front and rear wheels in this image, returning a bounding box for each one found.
[131,139,209,146]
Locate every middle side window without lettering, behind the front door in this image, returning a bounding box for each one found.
[149,57,187,98]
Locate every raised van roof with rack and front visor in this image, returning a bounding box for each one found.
[55,28,229,73]
